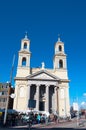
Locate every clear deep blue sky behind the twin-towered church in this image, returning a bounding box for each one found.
[0,0,86,103]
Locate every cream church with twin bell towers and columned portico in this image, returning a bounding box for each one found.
[13,34,70,116]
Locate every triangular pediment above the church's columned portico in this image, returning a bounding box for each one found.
[27,70,60,80]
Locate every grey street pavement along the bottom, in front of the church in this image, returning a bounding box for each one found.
[0,118,86,130]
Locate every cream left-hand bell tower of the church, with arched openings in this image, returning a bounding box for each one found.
[16,34,31,77]
